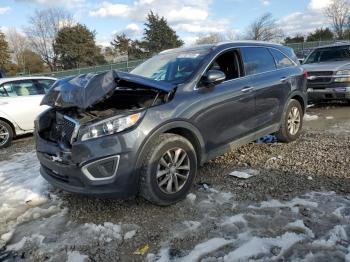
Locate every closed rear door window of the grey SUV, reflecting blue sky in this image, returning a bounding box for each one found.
[241,47,276,75]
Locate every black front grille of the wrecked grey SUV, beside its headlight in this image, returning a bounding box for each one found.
[50,113,76,145]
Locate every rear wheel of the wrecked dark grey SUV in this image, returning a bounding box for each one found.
[276,99,304,143]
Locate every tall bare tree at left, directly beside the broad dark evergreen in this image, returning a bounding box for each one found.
[26,8,74,71]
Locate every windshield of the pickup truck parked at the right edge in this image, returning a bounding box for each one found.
[304,46,350,64]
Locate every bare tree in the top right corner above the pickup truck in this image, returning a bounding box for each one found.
[324,0,350,39]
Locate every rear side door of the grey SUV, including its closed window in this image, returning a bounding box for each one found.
[241,47,289,130]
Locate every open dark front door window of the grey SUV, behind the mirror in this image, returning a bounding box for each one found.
[209,51,242,80]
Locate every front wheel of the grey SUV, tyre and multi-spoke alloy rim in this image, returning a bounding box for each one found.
[140,134,197,206]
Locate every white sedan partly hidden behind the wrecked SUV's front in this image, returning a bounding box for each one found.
[0,77,56,148]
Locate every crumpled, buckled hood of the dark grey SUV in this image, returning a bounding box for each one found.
[41,70,174,109]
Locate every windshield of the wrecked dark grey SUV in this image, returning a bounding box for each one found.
[131,49,209,84]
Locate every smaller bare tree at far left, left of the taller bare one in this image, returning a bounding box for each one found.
[6,28,28,71]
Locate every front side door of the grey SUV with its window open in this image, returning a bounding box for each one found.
[194,50,255,152]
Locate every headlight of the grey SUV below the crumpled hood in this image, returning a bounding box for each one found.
[79,113,142,141]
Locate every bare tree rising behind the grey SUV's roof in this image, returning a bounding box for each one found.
[246,13,284,41]
